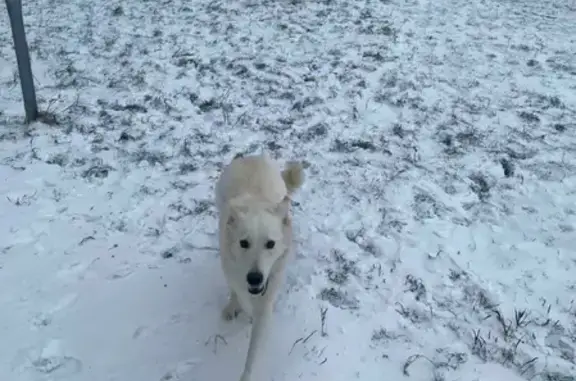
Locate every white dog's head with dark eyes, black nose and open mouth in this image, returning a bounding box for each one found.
[226,197,290,295]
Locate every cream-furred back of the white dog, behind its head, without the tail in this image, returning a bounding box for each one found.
[216,153,288,210]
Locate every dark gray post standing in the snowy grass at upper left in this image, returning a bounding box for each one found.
[6,0,38,123]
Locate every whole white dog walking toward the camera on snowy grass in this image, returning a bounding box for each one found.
[216,152,304,381]
